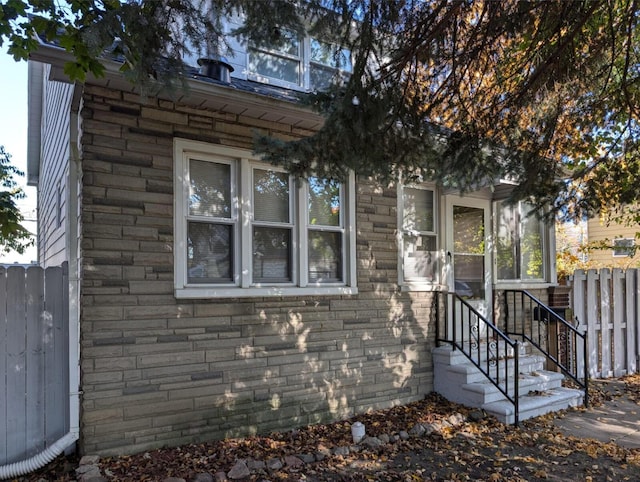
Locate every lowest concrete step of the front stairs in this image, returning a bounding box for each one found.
[482,387,584,424]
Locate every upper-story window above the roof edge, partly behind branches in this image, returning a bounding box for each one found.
[247,30,351,90]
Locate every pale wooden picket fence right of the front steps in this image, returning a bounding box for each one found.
[571,269,640,378]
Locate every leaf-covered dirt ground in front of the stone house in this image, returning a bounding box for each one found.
[11,376,640,482]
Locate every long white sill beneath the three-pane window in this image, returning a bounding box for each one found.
[175,286,358,299]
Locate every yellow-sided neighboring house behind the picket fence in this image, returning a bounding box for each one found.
[586,218,640,269]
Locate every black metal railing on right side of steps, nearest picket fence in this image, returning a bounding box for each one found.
[504,290,589,407]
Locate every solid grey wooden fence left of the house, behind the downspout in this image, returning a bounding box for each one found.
[0,265,69,465]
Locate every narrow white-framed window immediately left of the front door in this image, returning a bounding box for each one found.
[399,186,441,284]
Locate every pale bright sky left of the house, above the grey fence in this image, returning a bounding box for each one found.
[0,46,37,263]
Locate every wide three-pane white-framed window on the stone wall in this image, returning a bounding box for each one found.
[174,139,356,297]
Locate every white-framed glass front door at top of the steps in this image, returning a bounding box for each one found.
[445,195,492,321]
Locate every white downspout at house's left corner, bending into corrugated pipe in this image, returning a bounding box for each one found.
[0,86,82,480]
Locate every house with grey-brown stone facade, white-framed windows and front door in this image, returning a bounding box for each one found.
[17,12,576,464]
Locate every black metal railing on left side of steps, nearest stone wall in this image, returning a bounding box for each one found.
[436,293,520,425]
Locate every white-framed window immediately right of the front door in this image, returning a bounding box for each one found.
[495,201,548,281]
